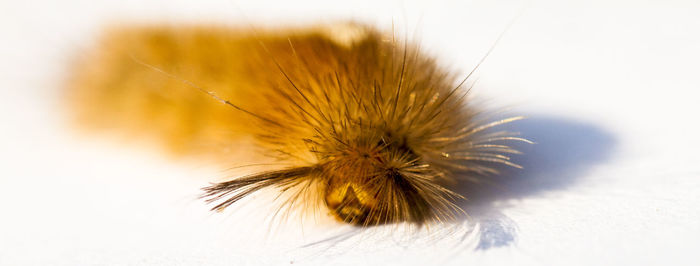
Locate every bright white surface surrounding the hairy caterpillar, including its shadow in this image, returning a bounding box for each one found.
[0,0,700,265]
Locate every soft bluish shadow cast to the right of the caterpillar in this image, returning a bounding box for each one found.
[455,116,617,250]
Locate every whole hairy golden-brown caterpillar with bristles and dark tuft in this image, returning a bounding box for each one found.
[69,23,526,226]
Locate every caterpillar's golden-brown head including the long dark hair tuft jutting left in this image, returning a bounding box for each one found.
[205,124,470,226]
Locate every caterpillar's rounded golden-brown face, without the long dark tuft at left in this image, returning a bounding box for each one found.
[320,130,458,226]
